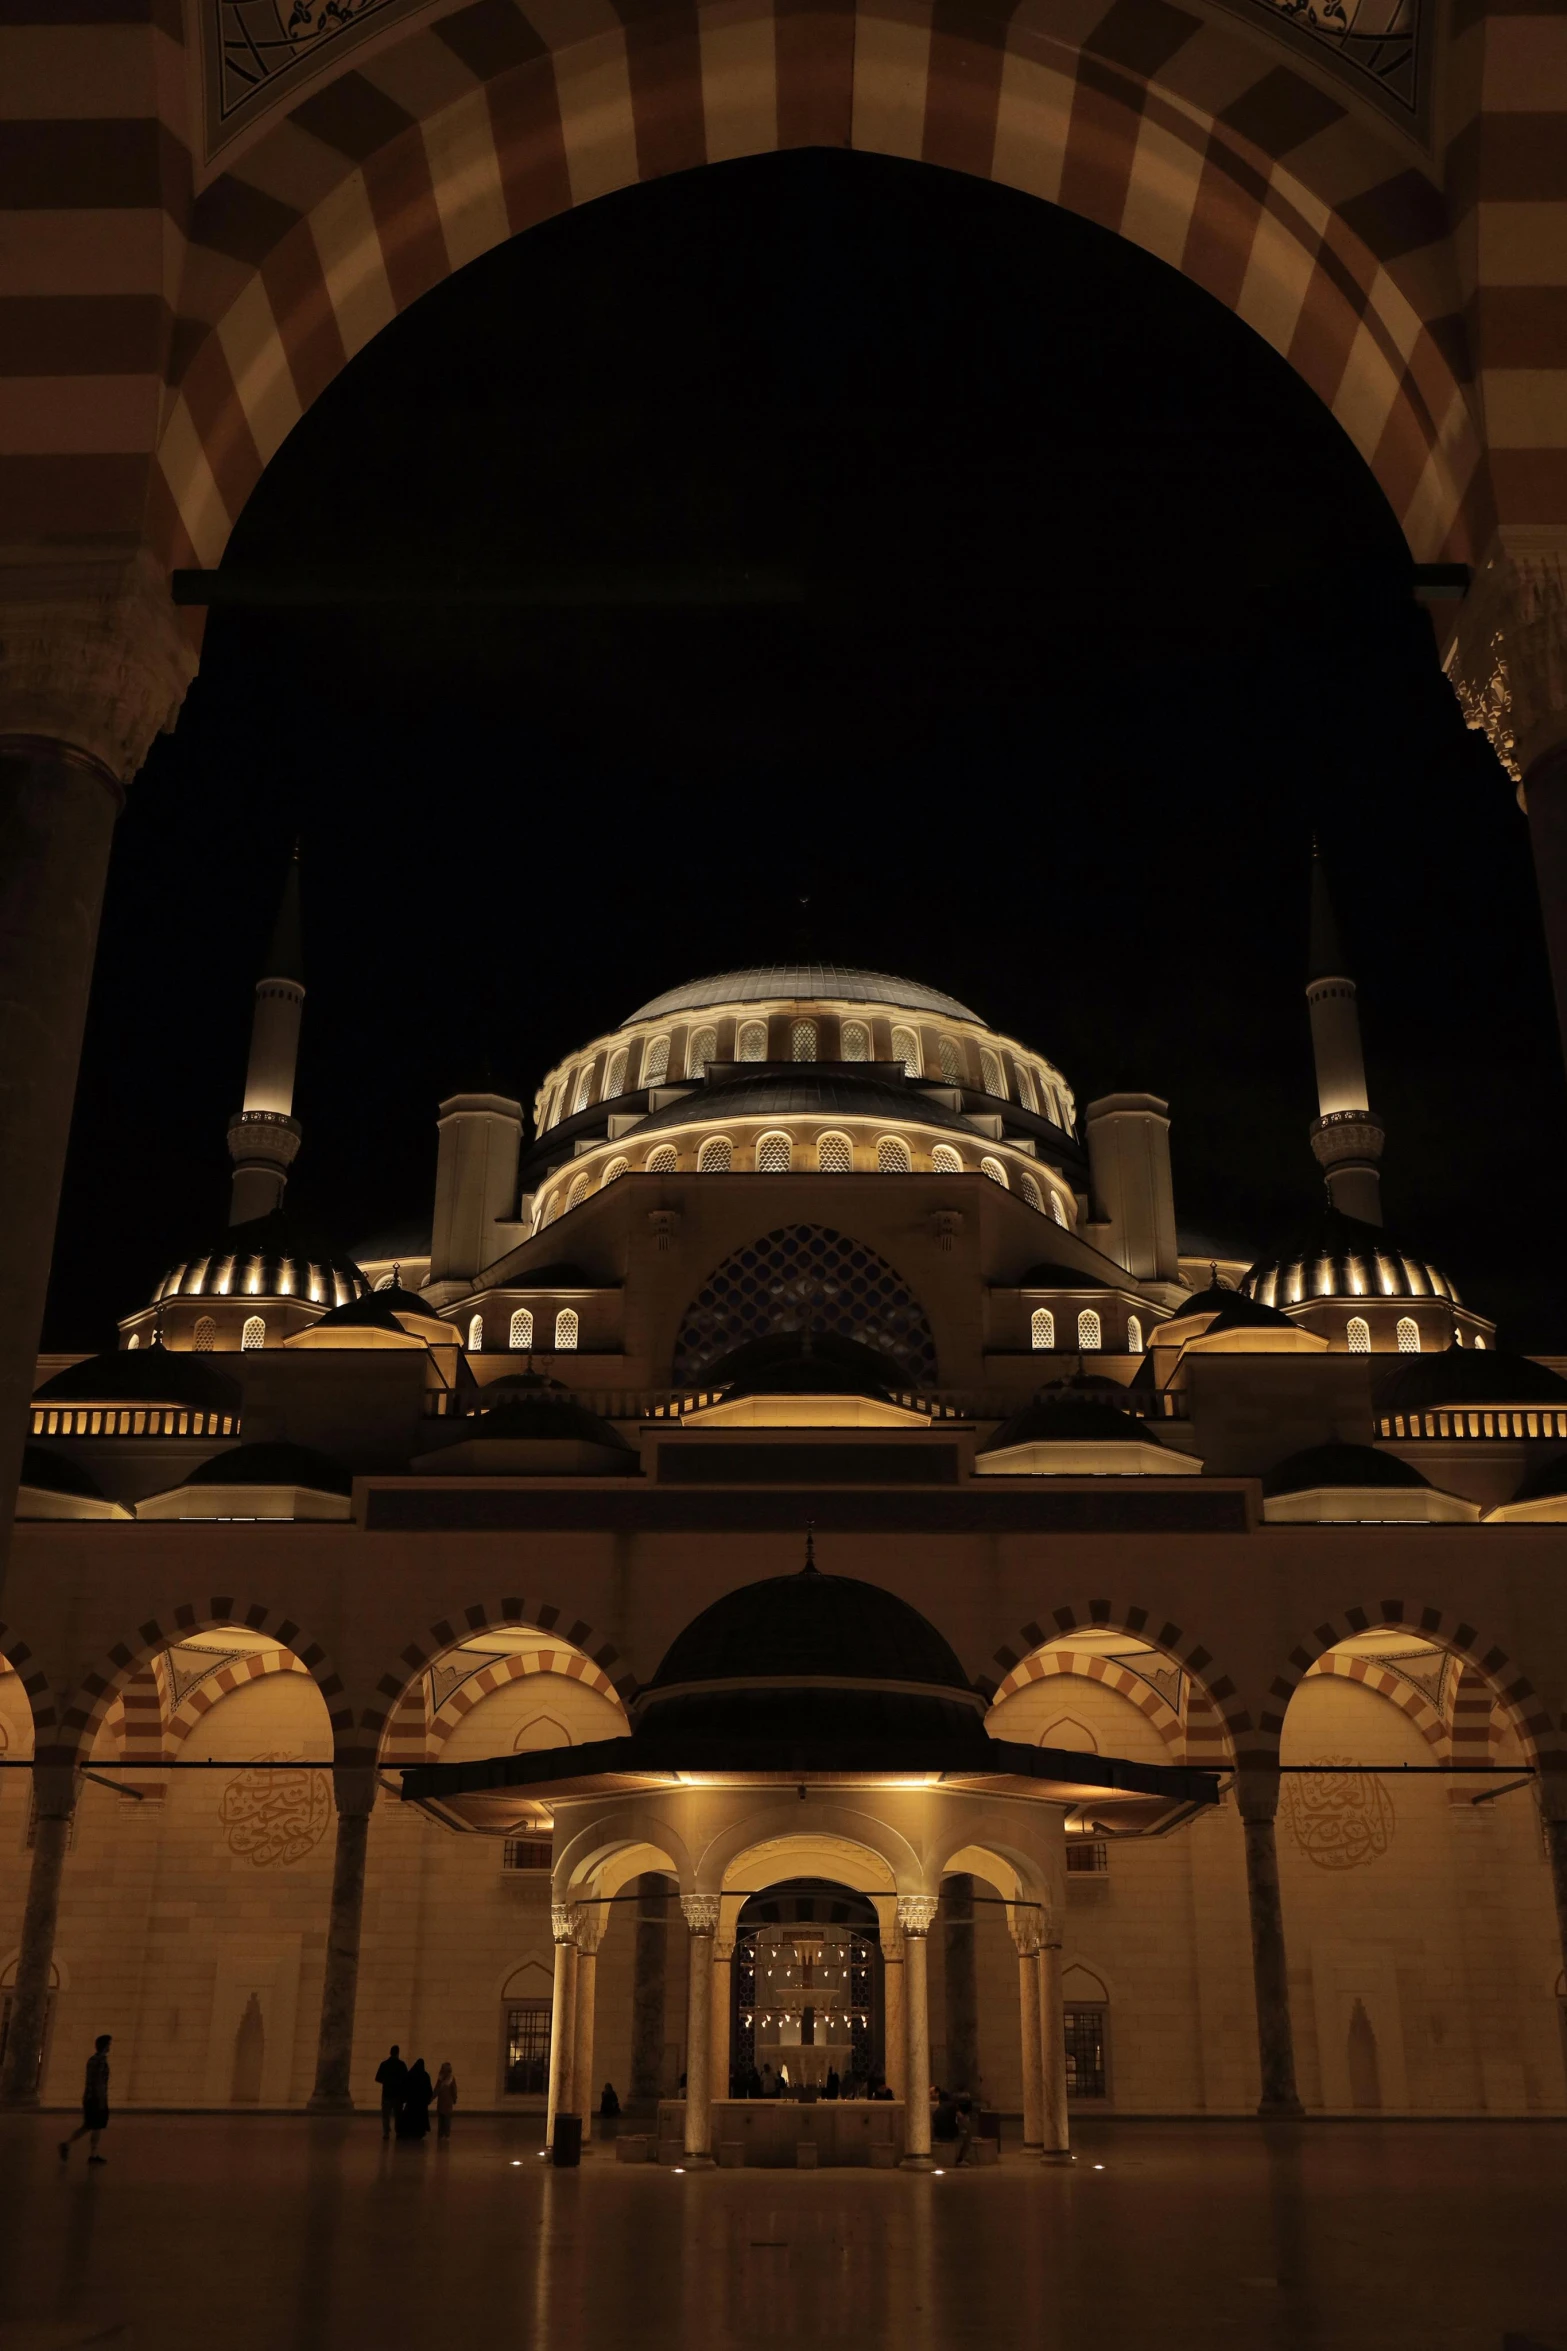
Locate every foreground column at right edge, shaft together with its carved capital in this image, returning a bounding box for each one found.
[1447,522,1567,1046]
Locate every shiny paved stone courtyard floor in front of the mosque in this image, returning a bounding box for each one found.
[0,2114,1567,2351]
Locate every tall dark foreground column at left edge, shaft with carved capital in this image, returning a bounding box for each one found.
[0,548,195,1579]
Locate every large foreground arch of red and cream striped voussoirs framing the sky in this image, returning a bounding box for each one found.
[153,0,1489,578]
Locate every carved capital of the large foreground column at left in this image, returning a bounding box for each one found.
[0,543,197,788]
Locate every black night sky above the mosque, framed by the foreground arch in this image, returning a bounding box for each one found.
[47,153,1567,1347]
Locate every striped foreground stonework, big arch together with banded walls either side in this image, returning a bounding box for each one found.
[0,0,1567,587]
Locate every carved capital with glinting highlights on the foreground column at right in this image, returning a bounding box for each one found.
[1447,522,1567,783]
